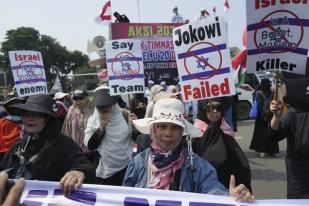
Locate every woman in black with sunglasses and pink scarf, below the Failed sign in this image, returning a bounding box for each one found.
[193,100,252,191]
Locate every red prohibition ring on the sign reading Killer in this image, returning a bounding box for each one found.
[254,9,304,53]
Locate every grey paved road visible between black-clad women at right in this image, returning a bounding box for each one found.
[236,120,286,199]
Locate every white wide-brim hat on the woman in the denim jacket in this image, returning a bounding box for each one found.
[133,98,202,137]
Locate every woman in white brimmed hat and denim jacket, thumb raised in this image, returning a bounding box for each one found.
[123,98,253,201]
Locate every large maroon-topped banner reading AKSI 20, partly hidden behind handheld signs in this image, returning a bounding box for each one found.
[111,23,182,85]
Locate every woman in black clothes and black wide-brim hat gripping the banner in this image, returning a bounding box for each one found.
[1,94,94,195]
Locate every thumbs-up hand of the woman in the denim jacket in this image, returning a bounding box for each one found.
[229,175,254,202]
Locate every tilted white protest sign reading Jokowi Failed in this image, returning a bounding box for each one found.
[173,17,235,101]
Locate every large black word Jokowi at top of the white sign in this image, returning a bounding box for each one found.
[174,17,221,46]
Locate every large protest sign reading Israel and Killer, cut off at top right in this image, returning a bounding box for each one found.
[246,0,309,74]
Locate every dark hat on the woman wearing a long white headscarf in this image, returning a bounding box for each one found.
[92,88,117,107]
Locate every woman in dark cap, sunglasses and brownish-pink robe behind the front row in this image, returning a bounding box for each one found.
[62,89,92,152]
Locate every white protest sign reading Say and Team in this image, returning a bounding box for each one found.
[105,39,145,95]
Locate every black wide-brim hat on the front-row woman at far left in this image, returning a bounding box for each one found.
[8,94,57,117]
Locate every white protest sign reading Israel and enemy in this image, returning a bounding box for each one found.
[9,51,48,97]
